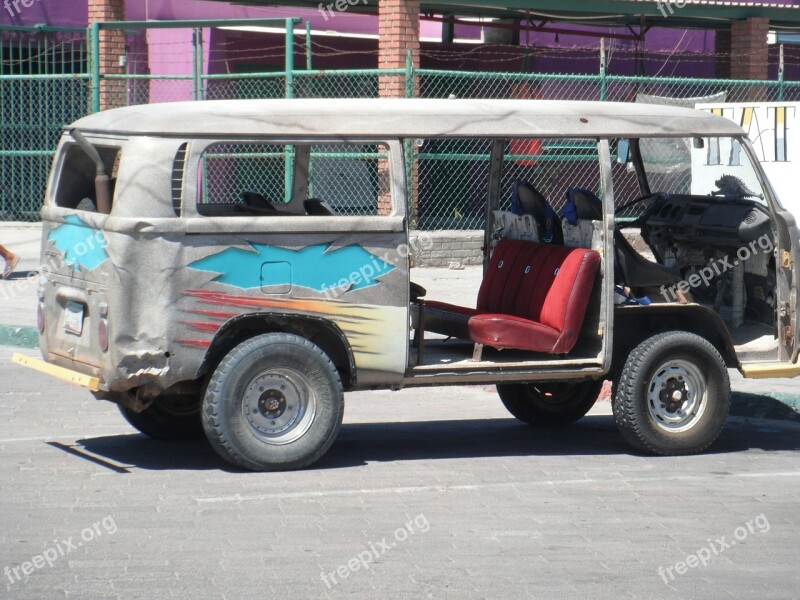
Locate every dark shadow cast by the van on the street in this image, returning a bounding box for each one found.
[73,416,800,472]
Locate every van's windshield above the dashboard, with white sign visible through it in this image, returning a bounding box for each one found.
[639,137,766,204]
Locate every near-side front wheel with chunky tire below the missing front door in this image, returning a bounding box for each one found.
[612,331,731,456]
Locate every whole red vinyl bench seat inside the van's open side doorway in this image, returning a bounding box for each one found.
[426,240,600,354]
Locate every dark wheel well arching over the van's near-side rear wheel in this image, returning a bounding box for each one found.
[198,313,356,390]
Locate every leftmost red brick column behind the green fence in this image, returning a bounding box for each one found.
[89,0,128,110]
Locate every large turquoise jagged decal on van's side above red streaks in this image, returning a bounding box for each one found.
[188,244,394,292]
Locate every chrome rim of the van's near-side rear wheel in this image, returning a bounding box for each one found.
[242,369,317,445]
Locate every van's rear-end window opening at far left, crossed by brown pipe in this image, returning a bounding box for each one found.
[55,144,121,212]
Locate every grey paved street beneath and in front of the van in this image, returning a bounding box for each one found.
[0,347,800,600]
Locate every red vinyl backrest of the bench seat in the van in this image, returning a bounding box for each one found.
[477,240,600,331]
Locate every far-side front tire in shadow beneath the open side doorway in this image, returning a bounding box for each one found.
[497,380,603,425]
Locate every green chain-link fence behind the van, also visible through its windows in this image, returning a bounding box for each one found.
[0,24,800,229]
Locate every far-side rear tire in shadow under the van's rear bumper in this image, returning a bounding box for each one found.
[117,396,204,440]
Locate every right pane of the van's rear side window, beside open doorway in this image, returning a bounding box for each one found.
[307,144,391,216]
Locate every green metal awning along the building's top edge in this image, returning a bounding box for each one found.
[217,0,800,31]
